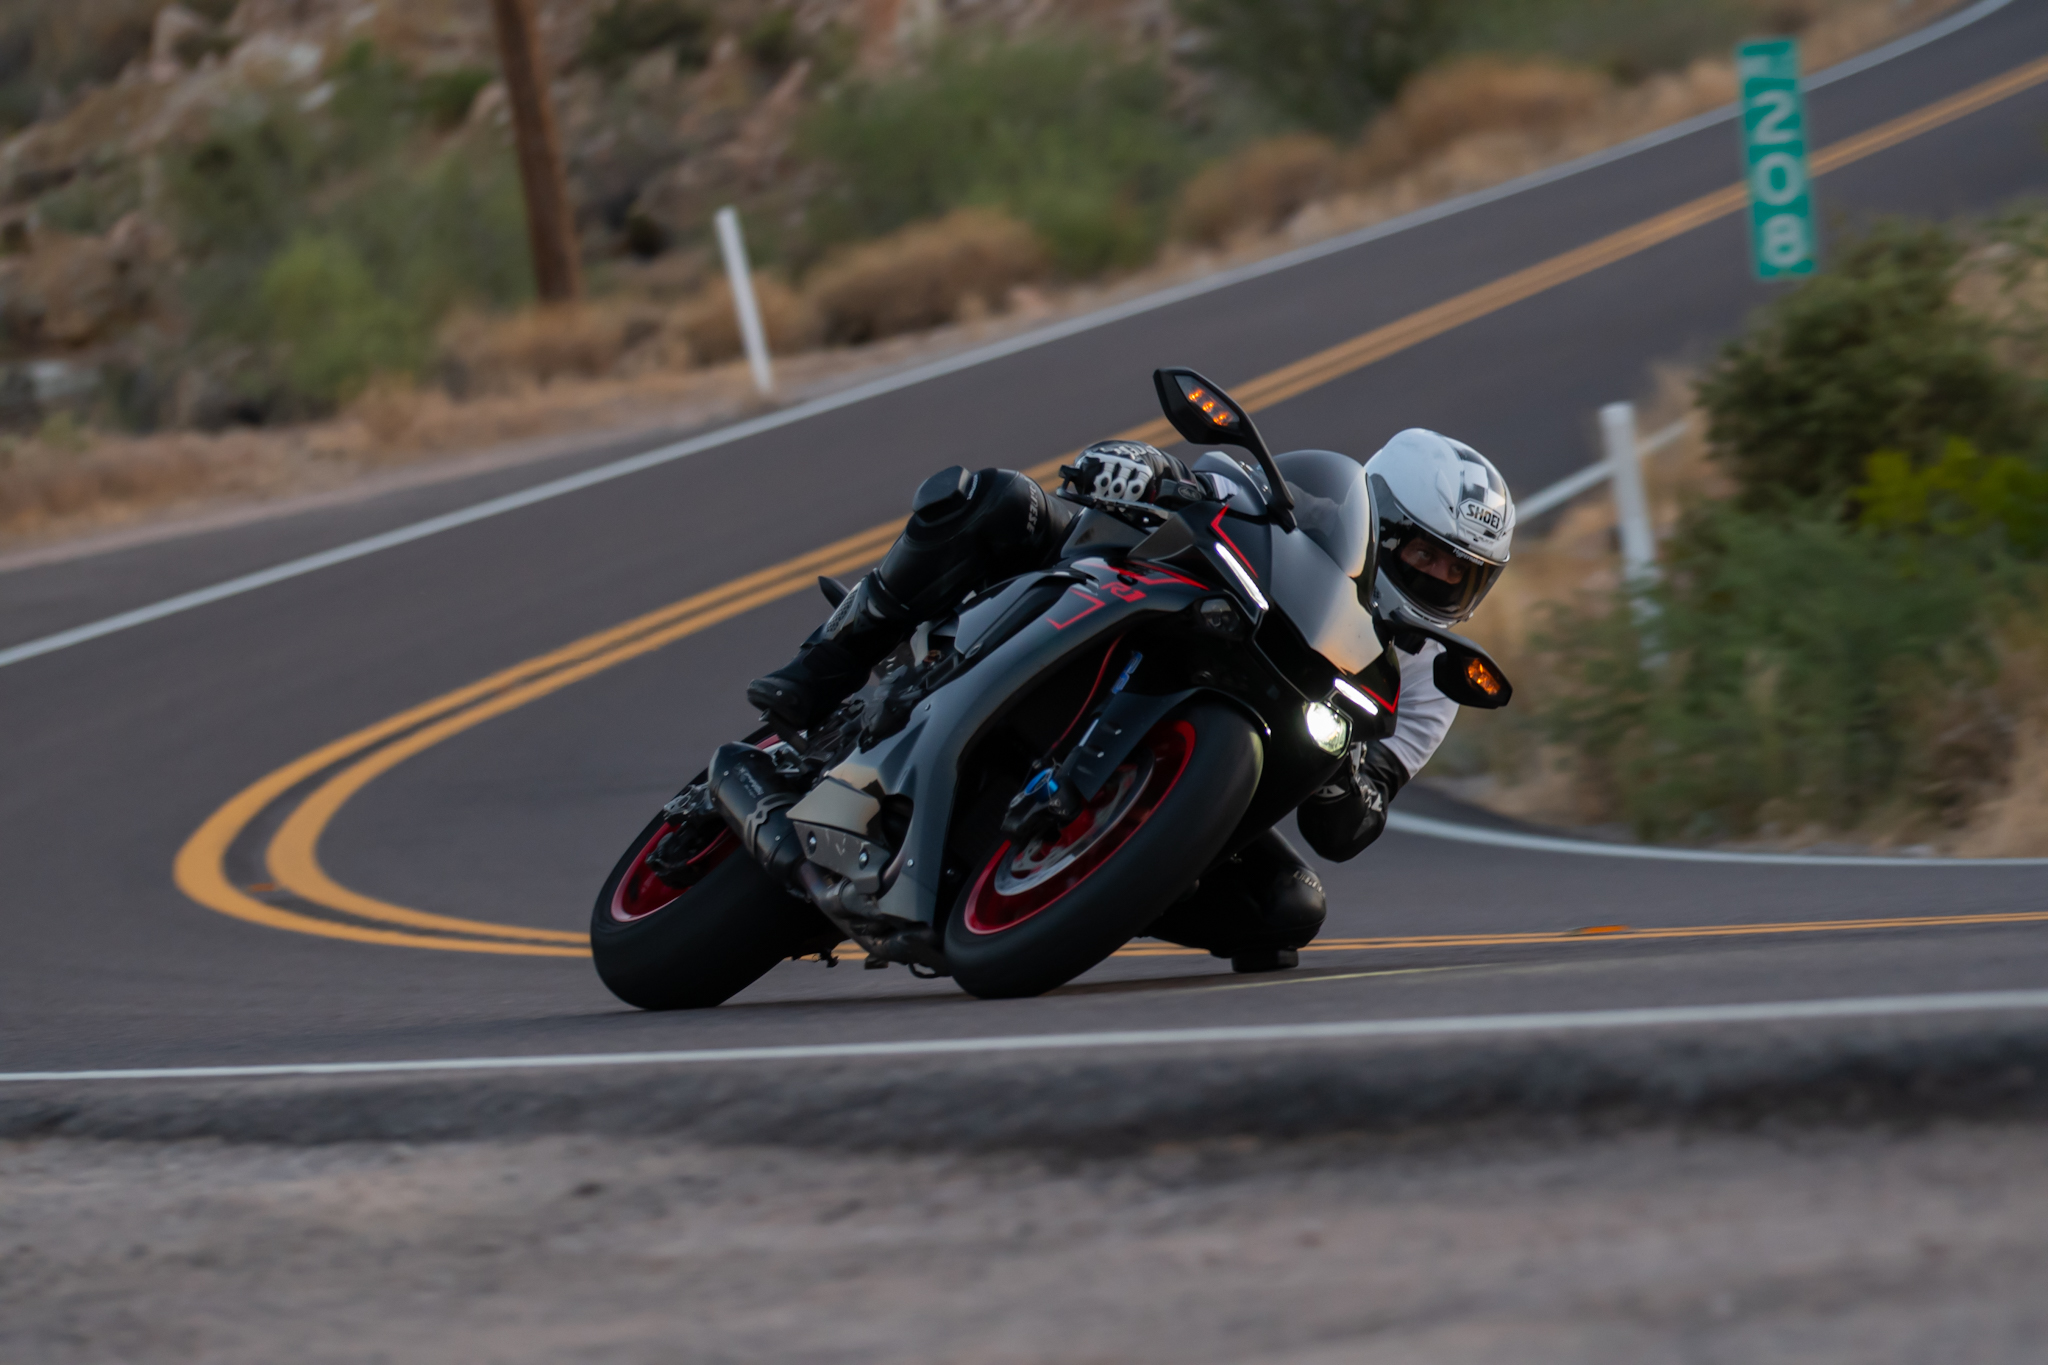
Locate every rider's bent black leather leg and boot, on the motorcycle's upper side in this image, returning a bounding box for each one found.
[748,465,1079,731]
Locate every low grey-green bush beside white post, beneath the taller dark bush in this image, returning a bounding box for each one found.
[1540,505,1999,839]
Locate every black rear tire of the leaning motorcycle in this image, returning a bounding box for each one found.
[590,817,840,1009]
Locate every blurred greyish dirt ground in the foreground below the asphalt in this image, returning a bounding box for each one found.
[0,1126,2048,1365]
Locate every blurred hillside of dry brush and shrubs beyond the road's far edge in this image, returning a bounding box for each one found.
[0,0,1952,532]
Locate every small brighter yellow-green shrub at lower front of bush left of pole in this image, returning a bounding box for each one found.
[258,235,426,405]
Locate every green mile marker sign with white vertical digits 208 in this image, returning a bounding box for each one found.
[1735,39,1815,280]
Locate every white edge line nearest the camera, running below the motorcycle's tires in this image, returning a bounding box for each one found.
[16,990,2048,1083]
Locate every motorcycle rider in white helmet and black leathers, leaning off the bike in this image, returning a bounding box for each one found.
[748,428,1516,972]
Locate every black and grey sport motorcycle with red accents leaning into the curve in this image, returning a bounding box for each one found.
[590,368,1511,1009]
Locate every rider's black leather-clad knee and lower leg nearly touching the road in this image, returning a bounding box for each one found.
[1145,829,1329,972]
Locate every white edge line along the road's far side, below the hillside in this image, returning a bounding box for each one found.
[0,0,2011,667]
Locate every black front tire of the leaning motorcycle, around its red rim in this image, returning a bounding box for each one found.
[946,702,1264,999]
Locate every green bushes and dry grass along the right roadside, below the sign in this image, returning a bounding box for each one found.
[1466,213,2048,853]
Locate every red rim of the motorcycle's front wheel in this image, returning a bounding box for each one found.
[961,720,1194,933]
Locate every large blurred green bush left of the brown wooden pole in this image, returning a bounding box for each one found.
[164,45,532,415]
